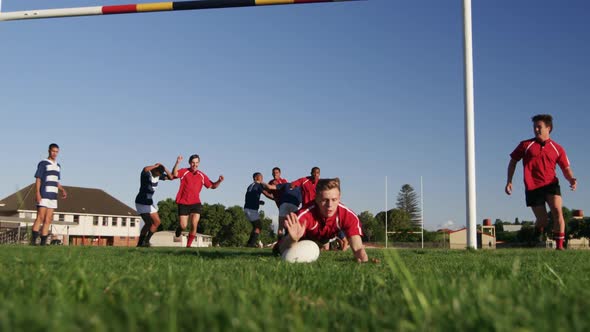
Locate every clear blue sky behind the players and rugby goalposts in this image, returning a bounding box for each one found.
[0,0,590,229]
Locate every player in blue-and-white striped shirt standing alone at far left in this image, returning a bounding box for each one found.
[31,143,68,246]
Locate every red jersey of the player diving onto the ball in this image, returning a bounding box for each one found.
[297,203,363,242]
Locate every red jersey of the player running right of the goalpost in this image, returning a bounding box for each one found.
[510,138,570,190]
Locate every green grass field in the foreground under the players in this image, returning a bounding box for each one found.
[0,246,590,331]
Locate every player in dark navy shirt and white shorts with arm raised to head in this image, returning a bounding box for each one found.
[135,163,174,247]
